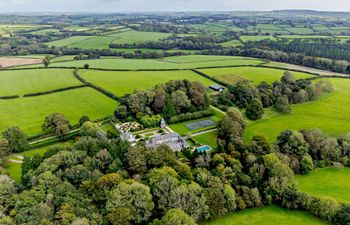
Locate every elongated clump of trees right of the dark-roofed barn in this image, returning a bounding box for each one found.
[216,71,333,120]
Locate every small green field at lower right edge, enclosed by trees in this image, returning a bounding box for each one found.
[297,167,350,203]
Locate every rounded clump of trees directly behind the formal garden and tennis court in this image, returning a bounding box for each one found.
[114,80,210,125]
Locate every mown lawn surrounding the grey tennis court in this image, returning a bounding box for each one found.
[169,110,224,136]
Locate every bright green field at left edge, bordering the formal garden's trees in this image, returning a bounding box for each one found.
[0,88,118,135]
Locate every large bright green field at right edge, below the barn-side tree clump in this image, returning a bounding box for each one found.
[245,78,350,141]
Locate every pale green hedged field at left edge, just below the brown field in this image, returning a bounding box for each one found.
[0,69,82,96]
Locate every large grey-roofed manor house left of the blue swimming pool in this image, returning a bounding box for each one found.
[146,133,190,151]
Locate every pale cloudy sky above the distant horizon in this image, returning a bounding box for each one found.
[0,0,350,13]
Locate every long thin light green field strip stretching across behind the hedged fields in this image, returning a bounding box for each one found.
[18,55,263,70]
